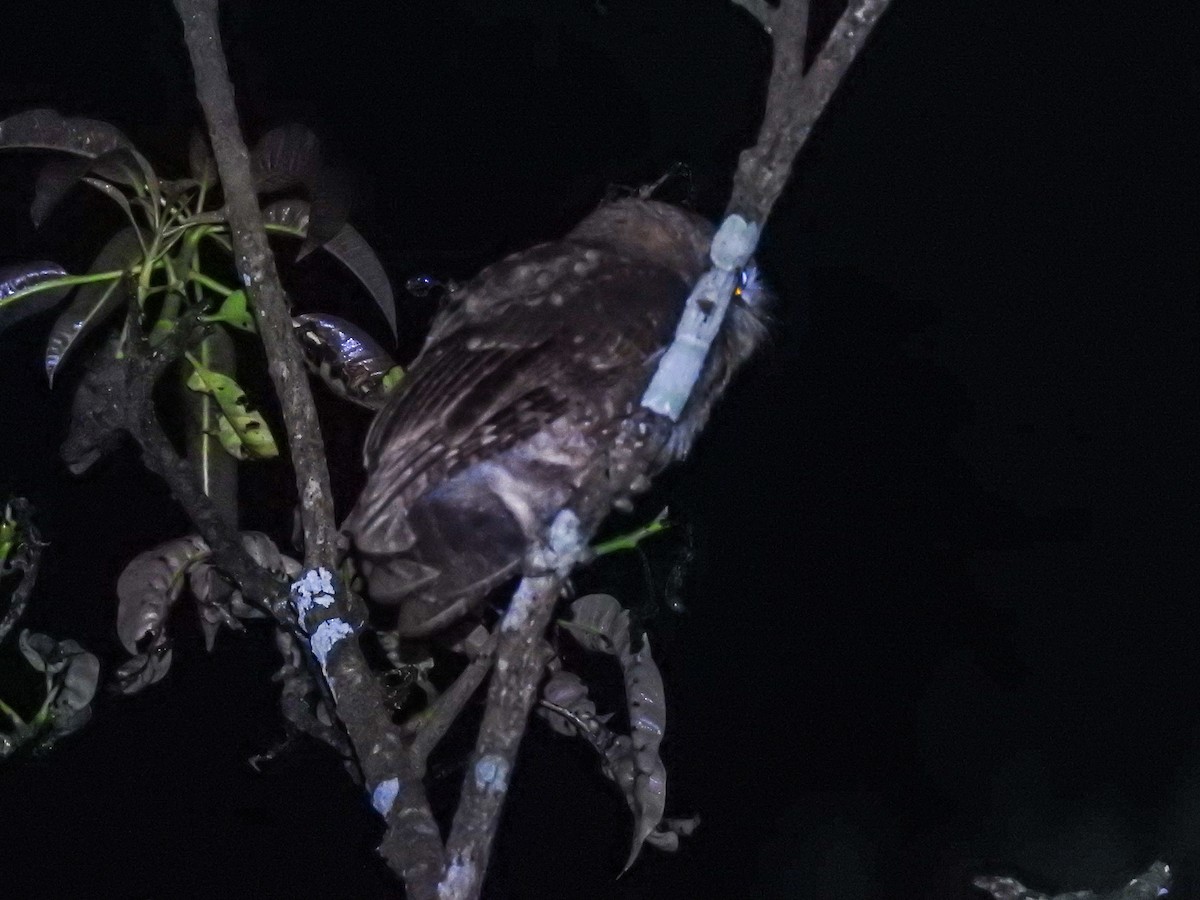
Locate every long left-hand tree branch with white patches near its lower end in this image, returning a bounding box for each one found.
[174,0,443,900]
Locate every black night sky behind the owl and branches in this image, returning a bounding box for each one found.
[0,0,1200,900]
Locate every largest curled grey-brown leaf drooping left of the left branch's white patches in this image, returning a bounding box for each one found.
[116,535,209,654]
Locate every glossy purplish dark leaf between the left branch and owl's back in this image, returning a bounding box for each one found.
[292,313,403,409]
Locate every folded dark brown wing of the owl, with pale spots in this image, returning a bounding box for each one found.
[343,244,688,578]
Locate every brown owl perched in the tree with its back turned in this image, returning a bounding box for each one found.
[343,199,766,636]
